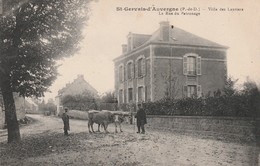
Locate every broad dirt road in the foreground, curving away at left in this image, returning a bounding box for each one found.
[0,115,259,166]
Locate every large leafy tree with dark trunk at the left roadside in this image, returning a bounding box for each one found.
[0,0,93,142]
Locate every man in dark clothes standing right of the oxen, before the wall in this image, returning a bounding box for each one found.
[135,104,147,134]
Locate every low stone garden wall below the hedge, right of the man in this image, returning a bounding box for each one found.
[147,115,260,140]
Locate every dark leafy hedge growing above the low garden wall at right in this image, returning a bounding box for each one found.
[144,82,260,117]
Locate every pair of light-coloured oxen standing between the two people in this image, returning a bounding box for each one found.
[88,110,130,133]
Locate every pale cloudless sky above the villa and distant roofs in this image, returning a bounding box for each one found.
[45,0,260,99]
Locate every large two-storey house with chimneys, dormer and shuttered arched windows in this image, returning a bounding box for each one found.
[114,21,227,104]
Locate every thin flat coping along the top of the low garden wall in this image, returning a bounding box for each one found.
[147,115,260,121]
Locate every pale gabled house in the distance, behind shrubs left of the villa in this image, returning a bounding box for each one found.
[55,75,98,114]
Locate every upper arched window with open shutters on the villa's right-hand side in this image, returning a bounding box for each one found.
[183,53,201,75]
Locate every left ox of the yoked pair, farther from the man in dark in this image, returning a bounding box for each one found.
[88,110,114,133]
